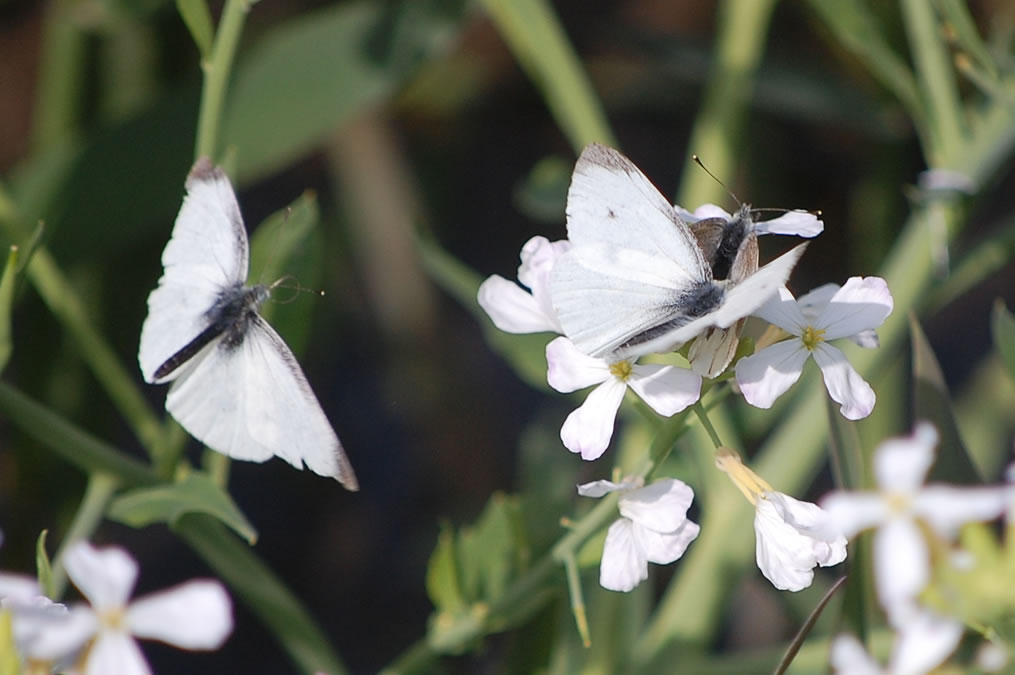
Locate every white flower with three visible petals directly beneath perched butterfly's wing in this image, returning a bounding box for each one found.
[546,337,701,460]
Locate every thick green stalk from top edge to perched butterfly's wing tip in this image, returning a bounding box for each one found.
[483,0,617,154]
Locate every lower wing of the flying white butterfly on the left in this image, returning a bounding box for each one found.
[165,317,358,490]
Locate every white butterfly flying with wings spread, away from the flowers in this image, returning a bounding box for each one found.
[137,157,358,490]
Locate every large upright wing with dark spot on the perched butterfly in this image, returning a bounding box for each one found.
[551,144,713,356]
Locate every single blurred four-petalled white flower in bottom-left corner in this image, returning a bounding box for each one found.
[26,541,232,675]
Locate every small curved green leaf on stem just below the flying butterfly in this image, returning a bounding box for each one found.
[109,473,257,545]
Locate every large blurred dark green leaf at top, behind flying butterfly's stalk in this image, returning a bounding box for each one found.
[222,0,464,182]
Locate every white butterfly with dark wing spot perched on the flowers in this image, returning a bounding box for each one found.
[550,144,807,358]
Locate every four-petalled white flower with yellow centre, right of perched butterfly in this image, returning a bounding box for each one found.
[737,277,892,419]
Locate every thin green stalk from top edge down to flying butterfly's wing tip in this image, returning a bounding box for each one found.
[194,0,251,159]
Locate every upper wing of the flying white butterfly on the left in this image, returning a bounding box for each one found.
[138,157,249,382]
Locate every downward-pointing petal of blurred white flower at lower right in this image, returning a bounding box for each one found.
[874,518,931,614]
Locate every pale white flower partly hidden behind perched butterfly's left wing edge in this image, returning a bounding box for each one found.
[478,237,570,333]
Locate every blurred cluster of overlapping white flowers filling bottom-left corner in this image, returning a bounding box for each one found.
[0,541,232,675]
